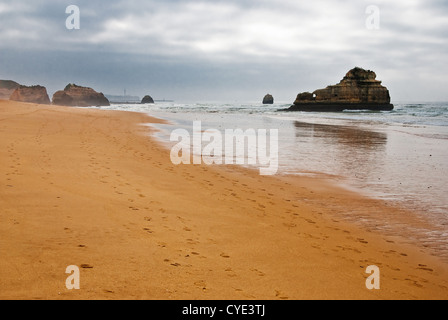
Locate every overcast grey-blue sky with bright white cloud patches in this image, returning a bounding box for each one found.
[0,0,448,103]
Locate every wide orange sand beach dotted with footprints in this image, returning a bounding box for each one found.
[0,101,448,300]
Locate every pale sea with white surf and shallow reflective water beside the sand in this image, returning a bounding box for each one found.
[94,102,448,259]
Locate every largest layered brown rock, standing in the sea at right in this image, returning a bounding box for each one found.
[287,67,394,111]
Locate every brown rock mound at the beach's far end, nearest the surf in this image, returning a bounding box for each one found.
[53,84,110,107]
